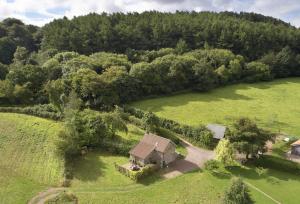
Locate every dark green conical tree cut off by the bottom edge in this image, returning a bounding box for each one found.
[222,178,253,204]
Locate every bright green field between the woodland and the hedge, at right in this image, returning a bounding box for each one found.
[131,78,300,137]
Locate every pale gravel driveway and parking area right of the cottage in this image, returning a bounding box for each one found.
[162,140,215,178]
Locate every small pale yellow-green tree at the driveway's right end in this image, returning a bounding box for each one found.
[215,139,235,166]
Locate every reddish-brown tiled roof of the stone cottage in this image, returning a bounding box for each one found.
[129,133,175,159]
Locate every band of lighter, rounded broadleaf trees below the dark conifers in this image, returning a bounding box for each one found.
[0,43,300,108]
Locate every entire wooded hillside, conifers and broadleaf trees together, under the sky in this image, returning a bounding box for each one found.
[0,11,300,110]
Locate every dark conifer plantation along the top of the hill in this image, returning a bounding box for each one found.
[42,11,299,59]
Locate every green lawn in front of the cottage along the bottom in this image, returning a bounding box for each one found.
[71,152,300,204]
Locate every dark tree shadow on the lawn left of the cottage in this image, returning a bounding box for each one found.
[73,152,106,181]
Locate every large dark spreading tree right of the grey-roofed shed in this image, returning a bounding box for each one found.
[227,118,274,159]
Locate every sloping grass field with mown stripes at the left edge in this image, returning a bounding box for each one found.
[0,113,64,203]
